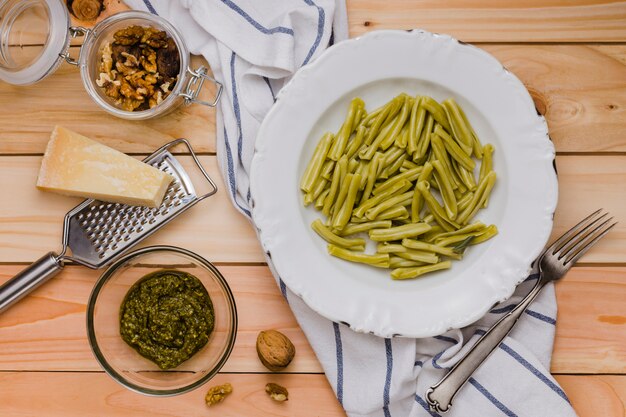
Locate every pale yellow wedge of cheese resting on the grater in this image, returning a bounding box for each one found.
[37,126,173,207]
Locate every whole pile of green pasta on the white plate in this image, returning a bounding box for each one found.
[300,93,498,280]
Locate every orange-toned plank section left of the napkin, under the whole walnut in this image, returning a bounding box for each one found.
[0,265,322,372]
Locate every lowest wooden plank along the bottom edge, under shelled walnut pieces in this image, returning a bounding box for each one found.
[0,372,626,417]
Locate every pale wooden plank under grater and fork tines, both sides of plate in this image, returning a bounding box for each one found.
[0,155,626,263]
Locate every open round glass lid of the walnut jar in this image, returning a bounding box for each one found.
[0,0,71,85]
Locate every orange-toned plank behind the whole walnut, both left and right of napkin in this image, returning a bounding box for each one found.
[0,265,626,373]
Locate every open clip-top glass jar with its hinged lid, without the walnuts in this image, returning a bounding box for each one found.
[0,0,222,120]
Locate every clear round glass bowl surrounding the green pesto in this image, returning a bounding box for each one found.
[87,246,237,396]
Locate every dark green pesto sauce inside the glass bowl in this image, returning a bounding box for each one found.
[120,270,215,369]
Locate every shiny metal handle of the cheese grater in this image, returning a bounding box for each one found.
[0,252,63,313]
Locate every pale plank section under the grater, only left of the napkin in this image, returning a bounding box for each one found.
[0,156,264,262]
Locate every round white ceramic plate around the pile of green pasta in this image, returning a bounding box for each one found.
[251,31,557,337]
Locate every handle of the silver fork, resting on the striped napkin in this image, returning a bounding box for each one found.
[426,278,546,413]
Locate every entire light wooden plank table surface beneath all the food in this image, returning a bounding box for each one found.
[0,0,626,417]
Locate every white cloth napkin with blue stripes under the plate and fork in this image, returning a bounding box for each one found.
[126,0,576,417]
